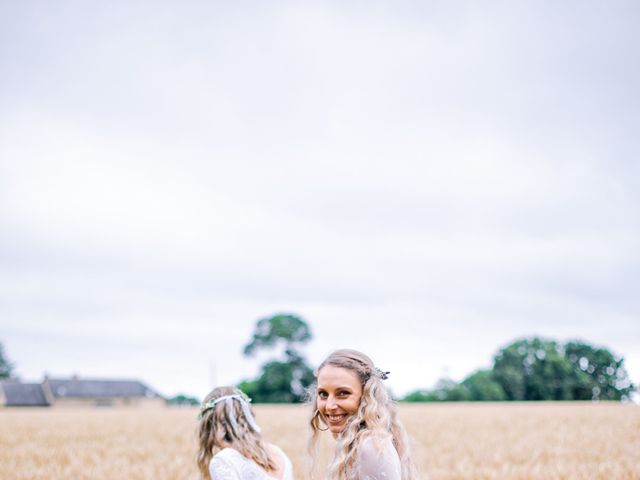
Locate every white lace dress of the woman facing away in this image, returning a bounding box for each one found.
[209,446,293,480]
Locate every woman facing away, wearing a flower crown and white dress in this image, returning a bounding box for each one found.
[197,387,293,480]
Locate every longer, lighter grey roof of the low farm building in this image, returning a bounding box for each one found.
[46,378,160,398]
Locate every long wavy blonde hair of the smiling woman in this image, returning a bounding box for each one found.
[308,349,417,480]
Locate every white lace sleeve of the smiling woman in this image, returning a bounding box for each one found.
[356,438,402,480]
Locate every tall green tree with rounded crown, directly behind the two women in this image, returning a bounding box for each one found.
[238,314,314,403]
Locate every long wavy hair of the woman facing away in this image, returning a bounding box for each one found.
[196,387,277,480]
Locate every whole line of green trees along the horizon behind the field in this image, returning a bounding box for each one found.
[0,314,636,404]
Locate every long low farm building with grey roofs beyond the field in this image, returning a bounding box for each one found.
[0,376,165,407]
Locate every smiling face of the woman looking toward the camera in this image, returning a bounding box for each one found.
[316,365,362,433]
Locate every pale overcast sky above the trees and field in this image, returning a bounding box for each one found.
[0,0,640,398]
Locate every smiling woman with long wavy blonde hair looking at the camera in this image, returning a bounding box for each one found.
[309,350,417,480]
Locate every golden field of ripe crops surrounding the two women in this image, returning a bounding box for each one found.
[0,403,640,480]
